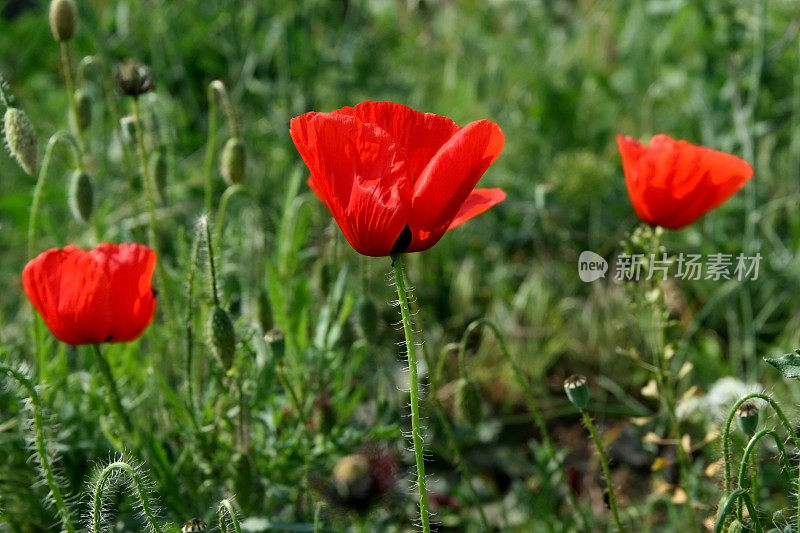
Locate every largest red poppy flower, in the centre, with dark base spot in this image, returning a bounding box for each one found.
[289,102,506,256]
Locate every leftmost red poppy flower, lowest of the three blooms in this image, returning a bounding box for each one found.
[22,243,156,344]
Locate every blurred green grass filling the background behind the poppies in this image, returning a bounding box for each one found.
[0,0,800,531]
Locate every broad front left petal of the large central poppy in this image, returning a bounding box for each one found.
[289,113,411,256]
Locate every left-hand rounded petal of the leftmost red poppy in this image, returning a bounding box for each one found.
[22,246,112,344]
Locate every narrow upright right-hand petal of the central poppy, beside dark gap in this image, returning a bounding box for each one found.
[409,120,505,251]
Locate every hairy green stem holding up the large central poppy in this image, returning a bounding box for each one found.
[392,254,431,533]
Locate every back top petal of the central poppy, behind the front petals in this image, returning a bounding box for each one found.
[334,102,461,180]
